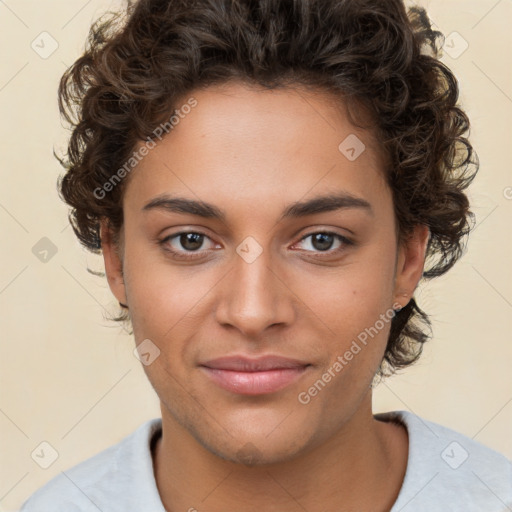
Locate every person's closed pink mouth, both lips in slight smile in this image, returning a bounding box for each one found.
[200,356,311,395]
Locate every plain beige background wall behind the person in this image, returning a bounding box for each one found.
[0,0,512,511]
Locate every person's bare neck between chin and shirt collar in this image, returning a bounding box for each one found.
[153,395,408,512]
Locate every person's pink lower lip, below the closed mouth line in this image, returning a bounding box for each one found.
[202,366,307,395]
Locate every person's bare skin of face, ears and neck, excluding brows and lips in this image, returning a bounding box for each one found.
[101,83,428,512]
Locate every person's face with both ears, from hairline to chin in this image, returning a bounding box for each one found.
[102,80,428,463]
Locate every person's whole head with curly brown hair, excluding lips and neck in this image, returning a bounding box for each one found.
[59,0,477,462]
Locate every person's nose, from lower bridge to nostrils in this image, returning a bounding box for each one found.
[216,244,295,339]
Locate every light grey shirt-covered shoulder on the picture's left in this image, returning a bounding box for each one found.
[20,418,161,512]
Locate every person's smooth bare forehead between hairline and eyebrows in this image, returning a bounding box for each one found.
[124,83,386,220]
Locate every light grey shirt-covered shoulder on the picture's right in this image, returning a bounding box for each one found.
[375,411,512,512]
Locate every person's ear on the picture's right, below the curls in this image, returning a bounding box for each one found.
[394,224,430,308]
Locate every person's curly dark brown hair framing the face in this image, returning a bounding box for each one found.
[55,0,478,376]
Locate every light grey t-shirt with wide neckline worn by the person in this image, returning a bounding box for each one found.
[20,411,512,512]
